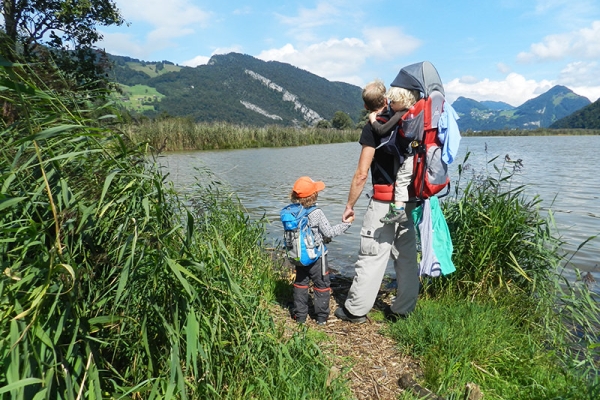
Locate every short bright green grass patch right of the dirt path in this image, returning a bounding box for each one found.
[388,298,592,399]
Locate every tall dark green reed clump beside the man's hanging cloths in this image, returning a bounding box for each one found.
[426,154,561,300]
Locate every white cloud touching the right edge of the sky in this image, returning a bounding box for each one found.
[517,21,600,62]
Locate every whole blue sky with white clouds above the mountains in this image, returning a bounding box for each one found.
[99,0,600,106]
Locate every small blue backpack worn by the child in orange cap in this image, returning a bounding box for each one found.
[280,203,325,266]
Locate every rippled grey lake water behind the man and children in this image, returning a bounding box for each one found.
[160,136,600,291]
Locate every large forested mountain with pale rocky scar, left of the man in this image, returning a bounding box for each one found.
[111,53,363,126]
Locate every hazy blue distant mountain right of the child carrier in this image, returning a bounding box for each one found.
[452,85,590,131]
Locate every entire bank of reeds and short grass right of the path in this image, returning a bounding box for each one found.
[388,154,600,399]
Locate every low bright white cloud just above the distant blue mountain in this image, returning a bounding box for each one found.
[444,73,555,106]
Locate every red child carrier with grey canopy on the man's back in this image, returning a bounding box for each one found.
[391,61,450,200]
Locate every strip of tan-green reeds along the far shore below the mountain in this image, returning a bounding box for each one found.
[122,118,360,151]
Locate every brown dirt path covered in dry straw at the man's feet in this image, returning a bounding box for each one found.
[274,270,424,400]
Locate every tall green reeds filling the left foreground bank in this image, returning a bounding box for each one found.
[0,61,348,400]
